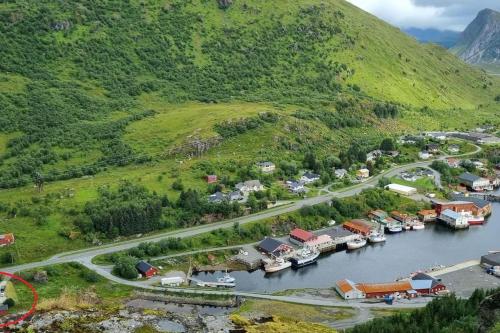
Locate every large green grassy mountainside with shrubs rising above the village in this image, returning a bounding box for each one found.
[0,0,500,261]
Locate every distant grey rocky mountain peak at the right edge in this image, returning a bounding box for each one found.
[451,9,500,72]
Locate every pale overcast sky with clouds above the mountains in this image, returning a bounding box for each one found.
[347,0,500,31]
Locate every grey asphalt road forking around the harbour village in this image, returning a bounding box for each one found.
[2,146,481,309]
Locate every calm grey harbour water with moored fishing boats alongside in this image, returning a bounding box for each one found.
[198,192,500,292]
